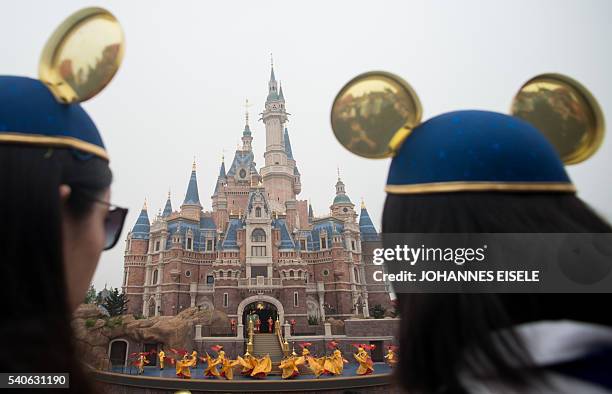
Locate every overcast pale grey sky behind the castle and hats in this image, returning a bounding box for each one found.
[0,0,612,288]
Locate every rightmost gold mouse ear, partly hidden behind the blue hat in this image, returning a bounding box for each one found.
[511,74,605,164]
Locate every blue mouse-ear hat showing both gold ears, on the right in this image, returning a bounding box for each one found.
[331,72,604,194]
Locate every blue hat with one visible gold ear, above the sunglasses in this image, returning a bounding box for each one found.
[0,7,125,161]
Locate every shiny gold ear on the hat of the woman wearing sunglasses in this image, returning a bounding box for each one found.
[38,7,125,104]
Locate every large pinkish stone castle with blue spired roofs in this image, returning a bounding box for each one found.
[123,67,390,333]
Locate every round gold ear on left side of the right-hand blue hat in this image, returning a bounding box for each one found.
[331,71,423,159]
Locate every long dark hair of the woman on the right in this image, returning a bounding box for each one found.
[382,192,612,393]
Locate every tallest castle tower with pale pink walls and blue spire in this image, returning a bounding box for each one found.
[261,62,302,214]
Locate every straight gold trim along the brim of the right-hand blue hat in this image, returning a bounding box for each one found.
[385,182,576,194]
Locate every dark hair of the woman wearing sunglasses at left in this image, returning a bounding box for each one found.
[0,145,112,393]
